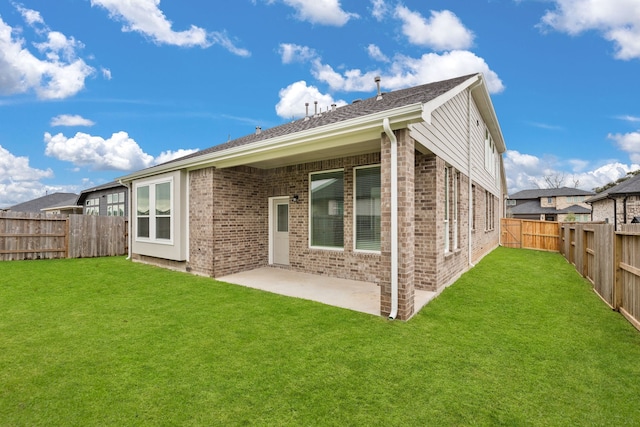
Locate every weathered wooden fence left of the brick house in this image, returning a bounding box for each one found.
[0,212,128,261]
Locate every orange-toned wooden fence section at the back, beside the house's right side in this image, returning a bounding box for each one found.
[500,218,560,252]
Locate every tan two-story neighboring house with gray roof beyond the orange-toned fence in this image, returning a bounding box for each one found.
[506,187,595,222]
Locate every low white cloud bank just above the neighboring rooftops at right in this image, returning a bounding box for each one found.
[504,150,640,194]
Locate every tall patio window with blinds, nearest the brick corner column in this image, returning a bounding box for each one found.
[353,165,381,252]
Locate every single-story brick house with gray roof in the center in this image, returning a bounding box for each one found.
[121,74,506,319]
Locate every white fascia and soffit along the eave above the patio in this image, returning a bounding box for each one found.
[119,103,423,182]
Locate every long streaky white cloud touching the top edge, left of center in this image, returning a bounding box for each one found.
[91,0,249,56]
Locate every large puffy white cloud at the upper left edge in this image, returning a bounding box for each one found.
[0,13,95,99]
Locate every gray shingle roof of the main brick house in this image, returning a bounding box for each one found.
[162,74,476,167]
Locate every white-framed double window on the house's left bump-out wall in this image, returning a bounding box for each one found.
[135,179,173,243]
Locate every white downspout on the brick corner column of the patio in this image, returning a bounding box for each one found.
[382,117,398,320]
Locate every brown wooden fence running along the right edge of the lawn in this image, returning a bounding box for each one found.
[560,223,640,330]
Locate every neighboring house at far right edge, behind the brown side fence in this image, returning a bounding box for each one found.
[587,174,640,230]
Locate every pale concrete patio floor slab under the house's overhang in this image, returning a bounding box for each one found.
[216,267,437,316]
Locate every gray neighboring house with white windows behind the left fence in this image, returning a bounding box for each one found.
[77,181,129,216]
